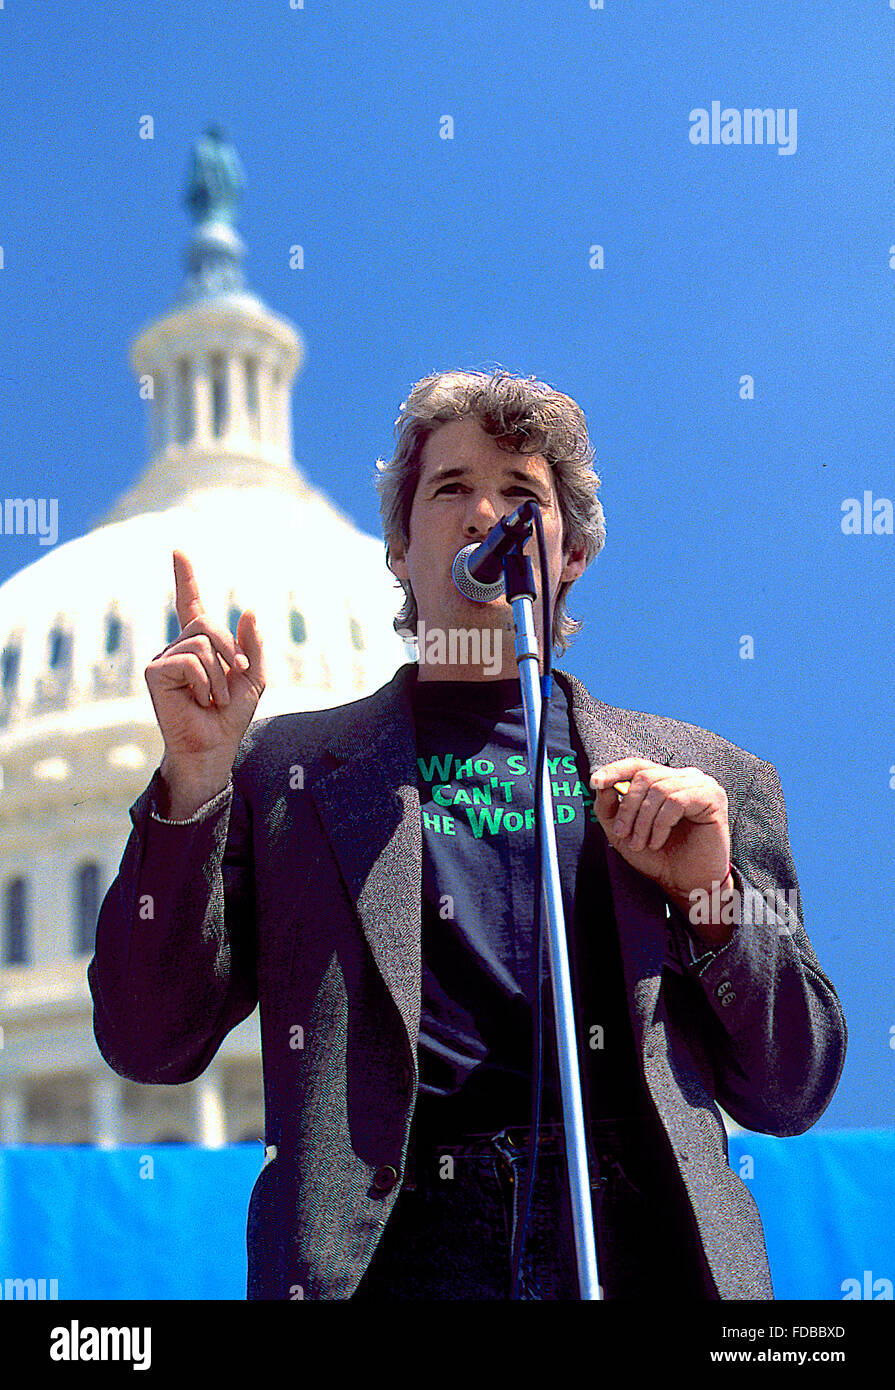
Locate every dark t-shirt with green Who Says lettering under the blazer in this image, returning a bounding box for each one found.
[411,673,645,1141]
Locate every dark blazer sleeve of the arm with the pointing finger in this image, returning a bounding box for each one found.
[88,769,257,1084]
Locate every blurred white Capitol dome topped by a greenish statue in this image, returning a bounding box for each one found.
[0,128,413,1144]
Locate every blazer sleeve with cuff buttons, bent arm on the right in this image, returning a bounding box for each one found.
[668,760,848,1136]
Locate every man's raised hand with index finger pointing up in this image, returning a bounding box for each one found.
[145,550,265,820]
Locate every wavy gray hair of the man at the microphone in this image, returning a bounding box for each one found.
[375,370,606,655]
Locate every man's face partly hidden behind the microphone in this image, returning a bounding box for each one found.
[389,416,585,678]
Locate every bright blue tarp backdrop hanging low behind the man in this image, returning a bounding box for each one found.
[0,1130,895,1300]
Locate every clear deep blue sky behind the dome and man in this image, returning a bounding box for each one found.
[0,0,895,1127]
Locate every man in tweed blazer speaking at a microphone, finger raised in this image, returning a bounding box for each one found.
[89,371,846,1300]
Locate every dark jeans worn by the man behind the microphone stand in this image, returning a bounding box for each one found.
[353,1122,717,1300]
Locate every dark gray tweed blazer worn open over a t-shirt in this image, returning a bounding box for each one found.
[88,664,846,1300]
